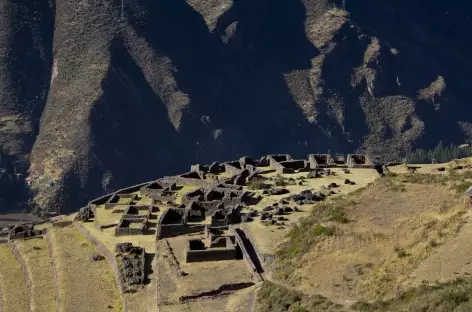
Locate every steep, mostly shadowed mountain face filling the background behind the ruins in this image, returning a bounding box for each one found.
[0,0,472,211]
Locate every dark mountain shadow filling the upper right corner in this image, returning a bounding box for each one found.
[338,0,472,147]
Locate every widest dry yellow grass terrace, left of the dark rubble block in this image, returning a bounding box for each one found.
[51,227,121,312]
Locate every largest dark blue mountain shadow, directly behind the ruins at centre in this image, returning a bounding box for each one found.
[125,0,334,162]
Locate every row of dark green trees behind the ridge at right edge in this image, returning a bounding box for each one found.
[406,142,472,164]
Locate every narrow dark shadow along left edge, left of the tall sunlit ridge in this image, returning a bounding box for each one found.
[6,1,55,143]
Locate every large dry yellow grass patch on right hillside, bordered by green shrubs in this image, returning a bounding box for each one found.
[296,180,470,303]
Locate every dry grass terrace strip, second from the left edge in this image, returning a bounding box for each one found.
[15,238,56,312]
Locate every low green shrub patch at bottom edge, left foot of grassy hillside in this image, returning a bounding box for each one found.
[257,281,344,312]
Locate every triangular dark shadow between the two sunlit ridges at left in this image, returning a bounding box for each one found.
[90,40,184,200]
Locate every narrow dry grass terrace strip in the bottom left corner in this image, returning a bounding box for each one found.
[0,244,30,312]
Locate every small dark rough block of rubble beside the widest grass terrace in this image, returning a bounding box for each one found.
[115,243,146,293]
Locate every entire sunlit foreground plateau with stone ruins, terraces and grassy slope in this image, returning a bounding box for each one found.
[0,154,472,312]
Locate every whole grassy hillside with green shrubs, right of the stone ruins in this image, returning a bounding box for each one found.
[259,159,472,311]
